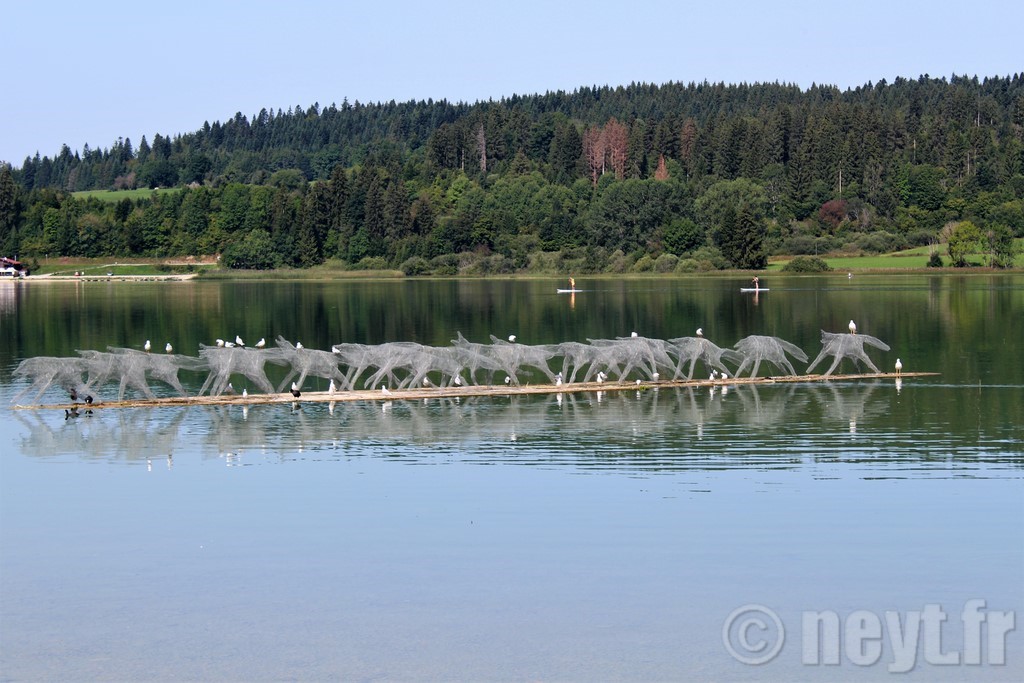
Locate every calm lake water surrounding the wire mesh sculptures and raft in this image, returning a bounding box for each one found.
[0,273,1024,681]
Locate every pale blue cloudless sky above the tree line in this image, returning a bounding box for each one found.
[0,0,1024,166]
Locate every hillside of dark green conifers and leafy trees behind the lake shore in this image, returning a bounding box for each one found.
[0,74,1024,273]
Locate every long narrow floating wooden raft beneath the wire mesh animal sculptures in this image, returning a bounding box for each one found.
[13,373,939,411]
